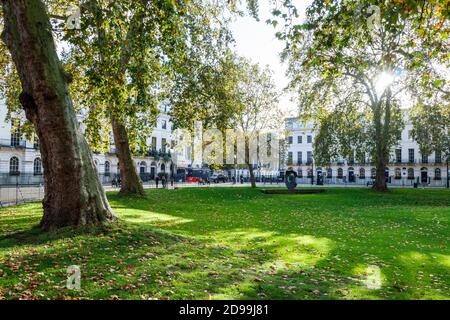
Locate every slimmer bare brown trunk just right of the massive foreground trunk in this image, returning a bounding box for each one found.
[111,117,144,195]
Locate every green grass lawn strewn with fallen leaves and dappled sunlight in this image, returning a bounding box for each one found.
[0,188,450,299]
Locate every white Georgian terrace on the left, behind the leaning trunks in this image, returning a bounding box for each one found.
[0,102,178,185]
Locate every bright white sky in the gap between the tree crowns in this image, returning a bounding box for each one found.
[231,0,311,116]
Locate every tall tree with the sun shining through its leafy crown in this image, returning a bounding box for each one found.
[270,0,450,191]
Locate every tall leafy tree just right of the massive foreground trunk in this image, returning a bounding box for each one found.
[59,0,243,194]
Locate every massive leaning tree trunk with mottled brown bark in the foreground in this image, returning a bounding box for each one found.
[2,0,114,230]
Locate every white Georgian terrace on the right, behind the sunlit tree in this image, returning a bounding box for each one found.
[285,118,449,187]
